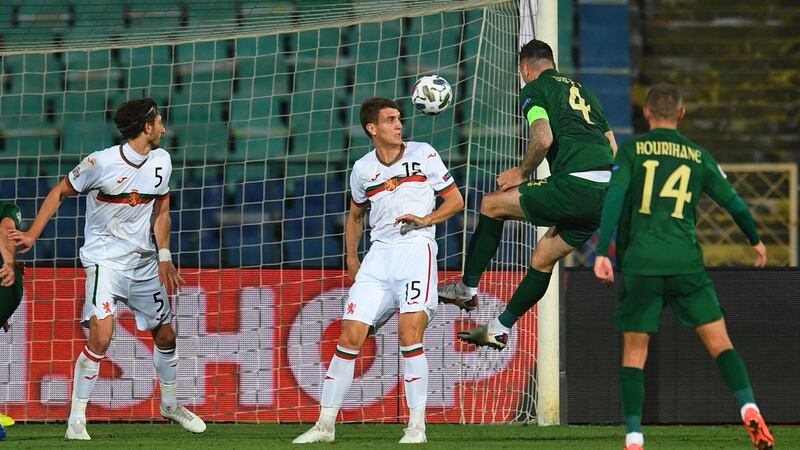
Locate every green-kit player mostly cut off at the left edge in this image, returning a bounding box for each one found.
[0,201,23,440]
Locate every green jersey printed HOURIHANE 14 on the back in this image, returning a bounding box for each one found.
[611,128,737,275]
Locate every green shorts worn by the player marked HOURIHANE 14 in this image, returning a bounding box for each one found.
[614,271,723,333]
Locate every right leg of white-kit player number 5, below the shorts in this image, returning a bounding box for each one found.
[150,323,206,433]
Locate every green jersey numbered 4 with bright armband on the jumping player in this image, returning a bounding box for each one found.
[519,69,614,174]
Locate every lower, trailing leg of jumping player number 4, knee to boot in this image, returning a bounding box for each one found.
[454,228,573,350]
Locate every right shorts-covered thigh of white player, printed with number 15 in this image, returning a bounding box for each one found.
[392,243,439,325]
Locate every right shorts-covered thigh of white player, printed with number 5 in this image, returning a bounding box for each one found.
[126,270,172,331]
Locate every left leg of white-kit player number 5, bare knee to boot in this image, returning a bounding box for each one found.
[64,312,114,440]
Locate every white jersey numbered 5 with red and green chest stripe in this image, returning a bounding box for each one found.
[67,144,172,270]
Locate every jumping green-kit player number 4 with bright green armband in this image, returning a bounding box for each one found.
[439,39,617,349]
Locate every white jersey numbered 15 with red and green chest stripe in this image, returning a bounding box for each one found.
[350,142,456,243]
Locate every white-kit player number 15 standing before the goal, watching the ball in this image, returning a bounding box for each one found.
[293,98,464,444]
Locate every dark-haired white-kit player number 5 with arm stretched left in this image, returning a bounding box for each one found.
[9,98,206,440]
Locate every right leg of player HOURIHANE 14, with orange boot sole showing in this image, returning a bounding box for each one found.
[697,319,775,449]
